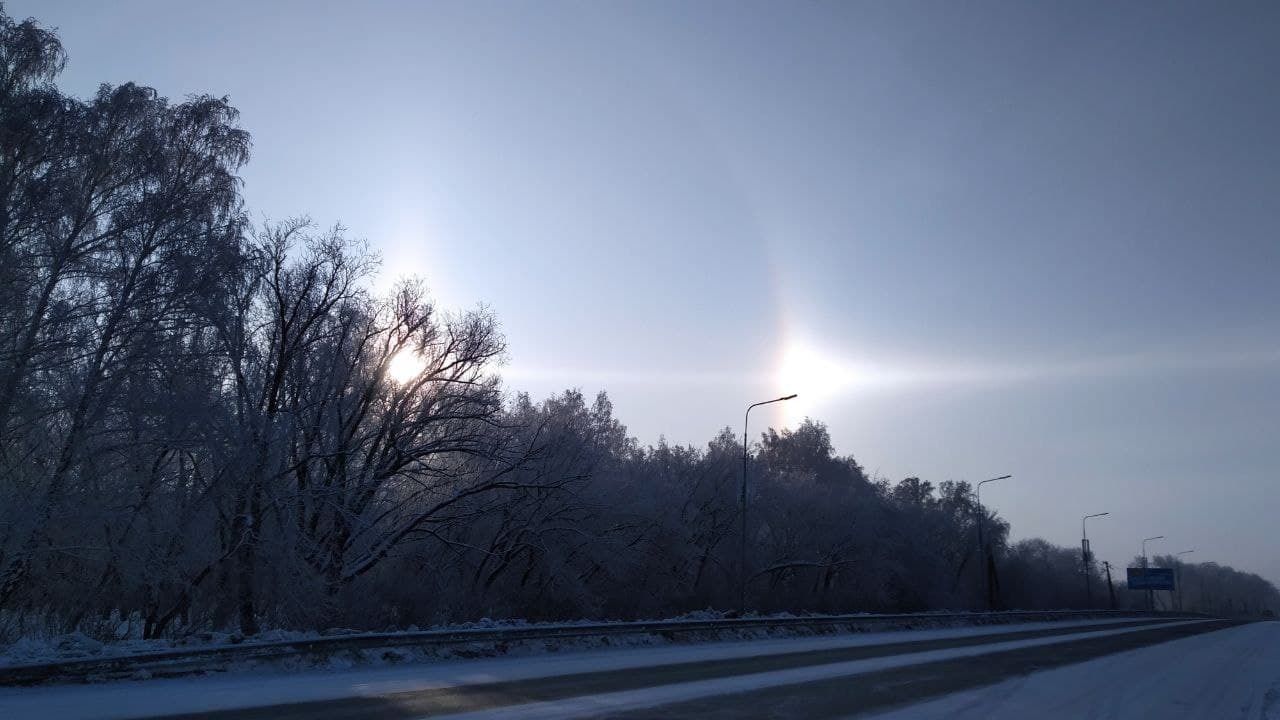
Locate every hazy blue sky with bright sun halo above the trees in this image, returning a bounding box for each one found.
[6,0,1280,580]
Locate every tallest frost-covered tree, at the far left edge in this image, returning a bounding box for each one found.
[0,2,248,607]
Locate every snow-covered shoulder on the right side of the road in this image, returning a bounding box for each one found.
[876,623,1280,720]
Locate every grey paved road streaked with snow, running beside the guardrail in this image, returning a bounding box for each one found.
[0,620,1229,720]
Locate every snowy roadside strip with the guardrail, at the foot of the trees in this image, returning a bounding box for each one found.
[0,611,1162,684]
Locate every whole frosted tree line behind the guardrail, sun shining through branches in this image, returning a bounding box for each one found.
[0,6,1280,641]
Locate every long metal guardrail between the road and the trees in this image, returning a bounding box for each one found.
[0,610,1197,685]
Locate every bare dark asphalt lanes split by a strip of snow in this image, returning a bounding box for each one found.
[145,620,1229,720]
